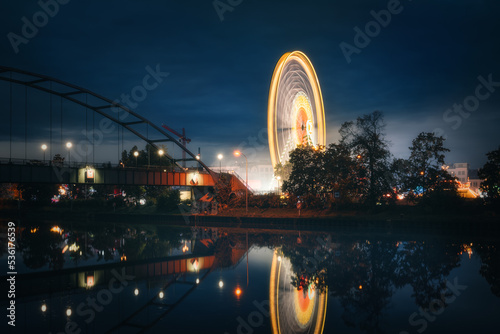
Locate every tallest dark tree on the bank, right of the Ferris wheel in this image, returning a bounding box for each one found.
[340,110,390,205]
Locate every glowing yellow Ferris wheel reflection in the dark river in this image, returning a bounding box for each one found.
[269,251,328,334]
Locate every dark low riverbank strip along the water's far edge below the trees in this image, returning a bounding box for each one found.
[0,206,500,226]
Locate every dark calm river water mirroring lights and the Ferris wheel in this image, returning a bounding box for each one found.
[1,222,500,334]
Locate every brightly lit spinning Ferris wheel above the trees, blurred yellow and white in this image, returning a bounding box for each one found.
[267,51,326,166]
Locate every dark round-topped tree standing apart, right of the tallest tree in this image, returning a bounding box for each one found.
[408,132,456,194]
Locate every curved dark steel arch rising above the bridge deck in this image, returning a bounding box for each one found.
[0,65,214,177]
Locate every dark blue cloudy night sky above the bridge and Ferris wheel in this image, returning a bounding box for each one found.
[0,0,500,168]
